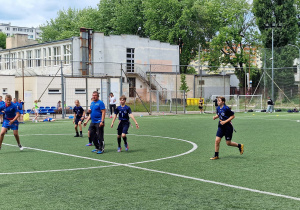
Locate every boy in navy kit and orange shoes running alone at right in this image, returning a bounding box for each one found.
[210,97,244,160]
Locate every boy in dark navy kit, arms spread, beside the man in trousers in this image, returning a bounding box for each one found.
[110,95,139,152]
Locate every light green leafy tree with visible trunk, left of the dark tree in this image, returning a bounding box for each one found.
[202,0,259,86]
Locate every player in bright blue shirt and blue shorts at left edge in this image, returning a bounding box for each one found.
[0,95,23,150]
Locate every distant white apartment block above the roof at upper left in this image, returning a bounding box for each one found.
[0,23,42,40]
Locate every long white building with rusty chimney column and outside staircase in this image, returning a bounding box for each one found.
[0,28,179,109]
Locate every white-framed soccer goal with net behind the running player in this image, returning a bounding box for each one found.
[211,95,263,112]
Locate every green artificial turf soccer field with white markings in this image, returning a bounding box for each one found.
[0,113,300,209]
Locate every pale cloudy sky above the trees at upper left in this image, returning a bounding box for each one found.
[0,0,100,27]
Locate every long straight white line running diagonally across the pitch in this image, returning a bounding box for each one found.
[5,144,300,201]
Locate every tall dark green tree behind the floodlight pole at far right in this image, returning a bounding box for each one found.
[253,0,299,100]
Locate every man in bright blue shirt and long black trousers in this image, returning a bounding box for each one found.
[83,91,105,154]
